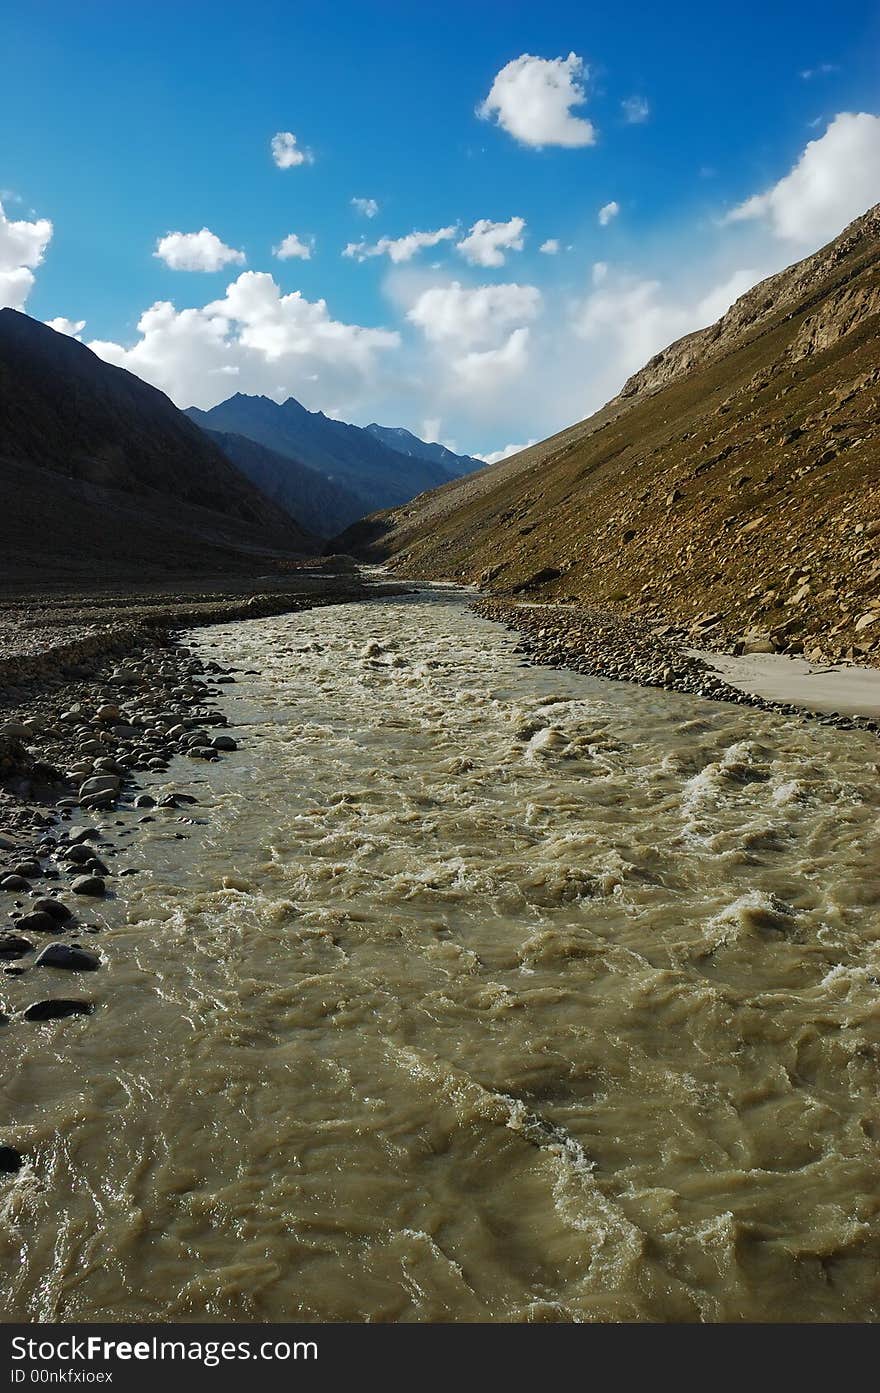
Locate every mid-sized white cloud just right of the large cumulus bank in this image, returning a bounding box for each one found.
[407,280,542,348]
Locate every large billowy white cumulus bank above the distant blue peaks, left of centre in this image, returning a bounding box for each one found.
[89,272,400,408]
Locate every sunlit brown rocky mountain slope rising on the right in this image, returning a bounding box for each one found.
[333,208,880,660]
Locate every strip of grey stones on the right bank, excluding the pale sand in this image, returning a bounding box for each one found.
[473,596,880,731]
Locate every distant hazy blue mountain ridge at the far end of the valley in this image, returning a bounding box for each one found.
[187,393,481,536]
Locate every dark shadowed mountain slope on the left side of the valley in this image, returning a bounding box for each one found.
[0,309,315,575]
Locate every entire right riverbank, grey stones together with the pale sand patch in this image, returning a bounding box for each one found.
[473,596,880,733]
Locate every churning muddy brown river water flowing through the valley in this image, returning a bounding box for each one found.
[0,588,880,1321]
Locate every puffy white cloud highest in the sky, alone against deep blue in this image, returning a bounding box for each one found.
[476,53,596,149]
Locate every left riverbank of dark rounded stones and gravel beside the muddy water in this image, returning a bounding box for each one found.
[0,567,400,1172]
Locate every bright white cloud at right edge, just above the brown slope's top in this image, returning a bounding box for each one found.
[725,111,880,251]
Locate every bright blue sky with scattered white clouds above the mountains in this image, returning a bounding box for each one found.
[0,0,880,453]
